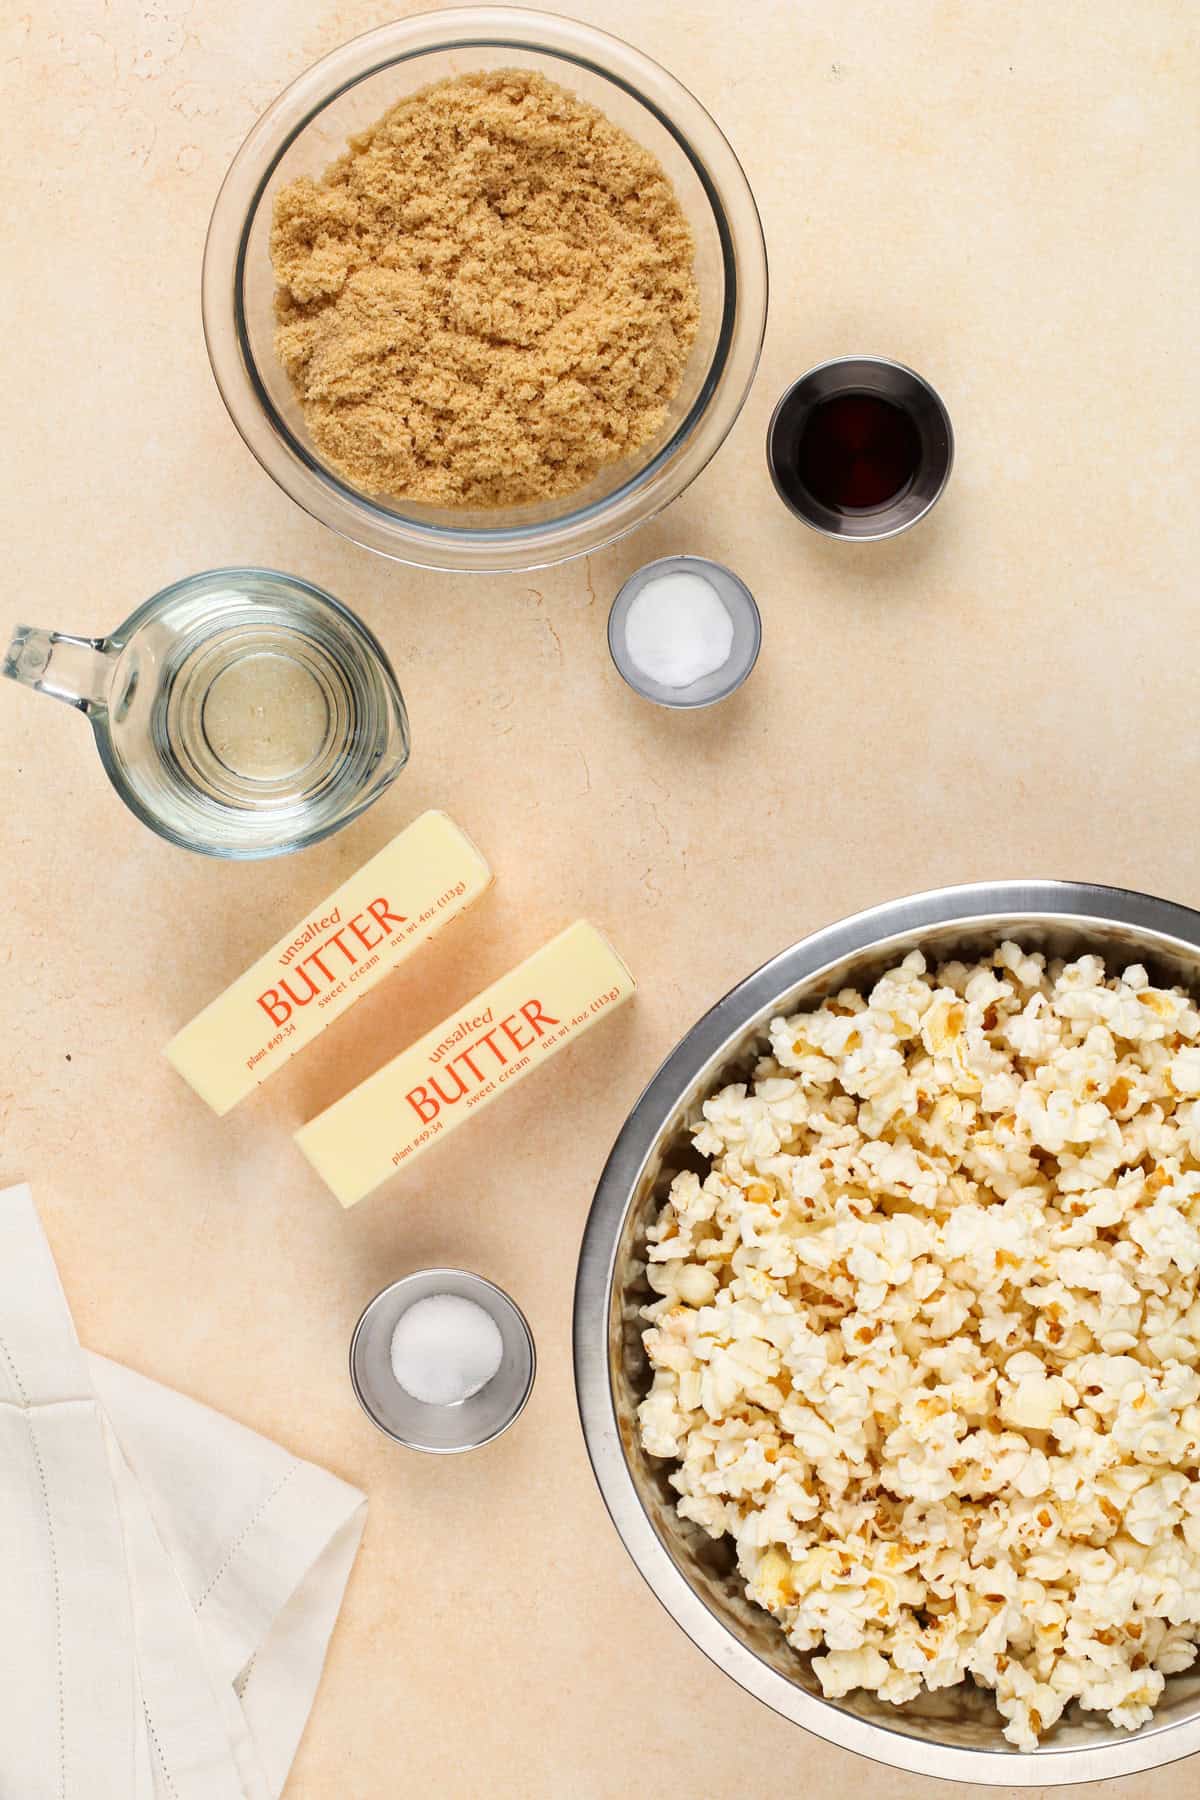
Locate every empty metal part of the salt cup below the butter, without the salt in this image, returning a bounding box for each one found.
[351,1269,538,1456]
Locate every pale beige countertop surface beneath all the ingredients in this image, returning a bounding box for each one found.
[0,0,1200,1800]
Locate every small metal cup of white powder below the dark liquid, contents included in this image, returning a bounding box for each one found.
[608,556,763,709]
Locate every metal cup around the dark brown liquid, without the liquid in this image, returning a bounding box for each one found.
[766,356,954,542]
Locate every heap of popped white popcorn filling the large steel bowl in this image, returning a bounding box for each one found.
[639,943,1200,1750]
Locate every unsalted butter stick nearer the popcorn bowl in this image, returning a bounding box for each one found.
[295,920,637,1206]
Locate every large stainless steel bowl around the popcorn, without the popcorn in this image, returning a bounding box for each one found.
[574,882,1200,1787]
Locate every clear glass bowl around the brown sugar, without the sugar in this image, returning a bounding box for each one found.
[203,7,766,571]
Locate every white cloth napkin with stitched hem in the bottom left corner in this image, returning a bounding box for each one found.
[0,1186,367,1800]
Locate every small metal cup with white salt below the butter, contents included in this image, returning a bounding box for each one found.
[351,1269,536,1456]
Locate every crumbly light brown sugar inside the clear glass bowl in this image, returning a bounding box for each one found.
[270,68,700,508]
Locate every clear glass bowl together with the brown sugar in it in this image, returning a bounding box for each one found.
[203,7,766,572]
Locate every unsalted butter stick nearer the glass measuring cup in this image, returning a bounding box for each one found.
[167,812,493,1112]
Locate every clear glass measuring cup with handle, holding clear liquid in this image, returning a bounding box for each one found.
[0,569,408,859]
